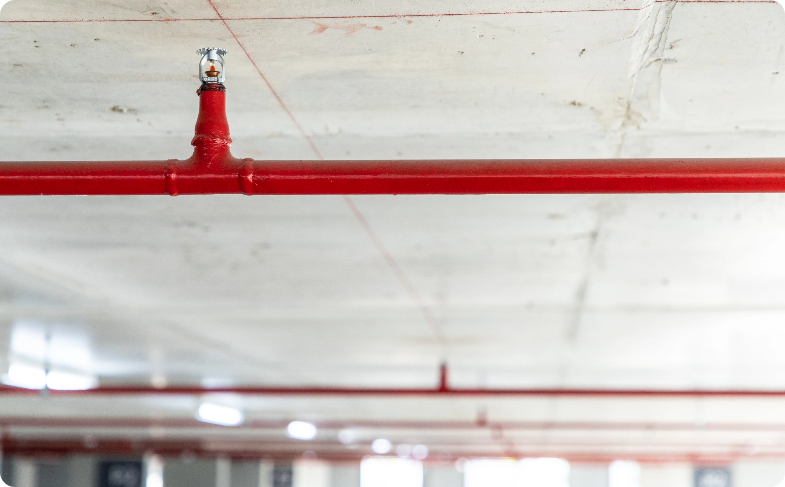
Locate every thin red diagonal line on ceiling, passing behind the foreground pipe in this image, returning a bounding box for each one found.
[207,0,446,346]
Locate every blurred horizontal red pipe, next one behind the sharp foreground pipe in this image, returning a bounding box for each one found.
[0,386,785,398]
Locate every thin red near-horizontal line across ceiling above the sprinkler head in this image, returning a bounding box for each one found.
[0,0,778,22]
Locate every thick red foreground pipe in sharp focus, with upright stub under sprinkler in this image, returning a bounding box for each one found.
[0,85,785,195]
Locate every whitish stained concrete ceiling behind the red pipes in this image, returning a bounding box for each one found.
[0,0,785,466]
